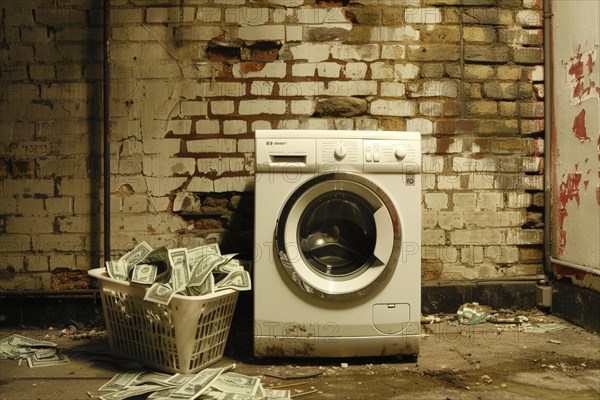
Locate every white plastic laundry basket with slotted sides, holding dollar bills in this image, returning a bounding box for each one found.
[88,268,238,374]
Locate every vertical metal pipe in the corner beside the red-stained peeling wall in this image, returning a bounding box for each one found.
[543,0,553,274]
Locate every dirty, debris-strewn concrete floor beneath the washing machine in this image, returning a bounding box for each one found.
[0,312,600,400]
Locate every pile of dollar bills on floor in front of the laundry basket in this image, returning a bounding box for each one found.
[98,364,290,400]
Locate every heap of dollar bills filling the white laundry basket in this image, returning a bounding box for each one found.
[106,242,252,305]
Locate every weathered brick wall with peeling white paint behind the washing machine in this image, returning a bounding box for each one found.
[0,0,544,290]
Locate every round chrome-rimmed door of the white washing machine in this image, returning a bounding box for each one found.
[275,173,401,301]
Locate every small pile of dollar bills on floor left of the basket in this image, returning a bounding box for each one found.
[0,334,69,368]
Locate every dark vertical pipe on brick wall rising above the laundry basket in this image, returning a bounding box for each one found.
[102,0,110,261]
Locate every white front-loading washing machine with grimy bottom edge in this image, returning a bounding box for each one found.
[253,130,421,357]
